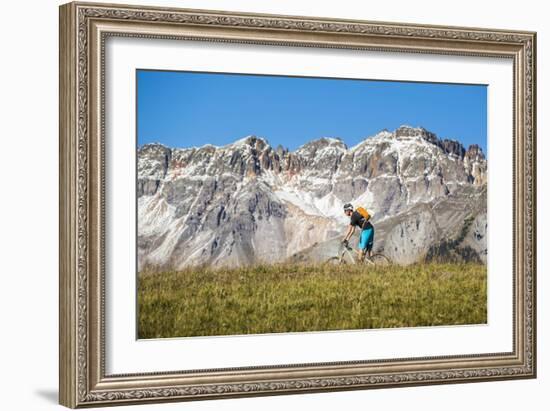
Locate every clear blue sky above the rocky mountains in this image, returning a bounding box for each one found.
[137,70,487,153]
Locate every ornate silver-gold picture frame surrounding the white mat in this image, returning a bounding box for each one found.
[59,3,536,407]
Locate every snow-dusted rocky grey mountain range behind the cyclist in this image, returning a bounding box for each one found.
[137,126,487,269]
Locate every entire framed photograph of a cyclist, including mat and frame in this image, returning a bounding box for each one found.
[60,3,536,408]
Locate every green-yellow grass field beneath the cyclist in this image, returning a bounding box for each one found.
[138,263,487,338]
